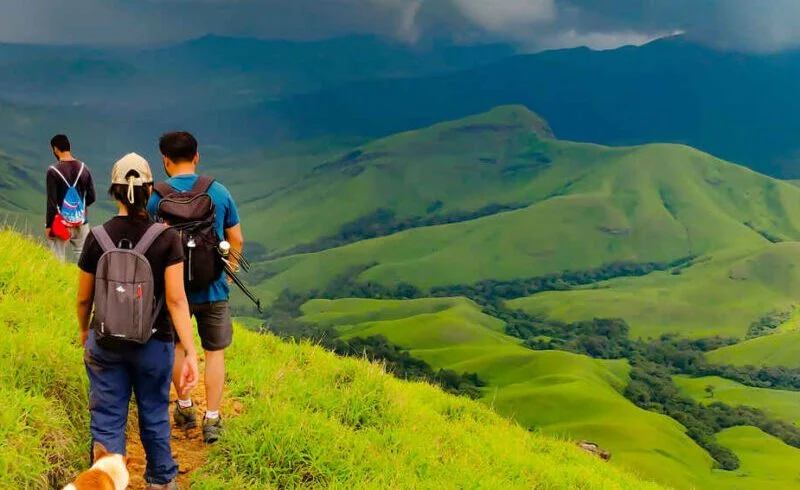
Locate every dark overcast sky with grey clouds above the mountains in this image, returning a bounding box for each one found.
[0,0,800,51]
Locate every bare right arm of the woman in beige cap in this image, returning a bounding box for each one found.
[164,262,200,390]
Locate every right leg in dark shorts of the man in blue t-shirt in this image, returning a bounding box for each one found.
[197,301,233,412]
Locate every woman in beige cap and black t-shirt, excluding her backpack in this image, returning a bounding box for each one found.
[78,153,199,489]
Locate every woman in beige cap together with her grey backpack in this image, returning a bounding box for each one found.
[78,153,199,490]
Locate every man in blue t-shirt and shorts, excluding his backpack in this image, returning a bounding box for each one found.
[147,132,244,443]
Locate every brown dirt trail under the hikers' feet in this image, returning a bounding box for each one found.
[128,356,209,490]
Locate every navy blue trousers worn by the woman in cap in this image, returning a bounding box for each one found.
[84,331,178,485]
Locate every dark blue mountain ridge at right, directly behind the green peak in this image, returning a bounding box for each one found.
[264,37,800,177]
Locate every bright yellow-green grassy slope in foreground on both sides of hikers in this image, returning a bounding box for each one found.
[0,232,656,489]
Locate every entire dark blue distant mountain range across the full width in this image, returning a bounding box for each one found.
[0,36,800,178]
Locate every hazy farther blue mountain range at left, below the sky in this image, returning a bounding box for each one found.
[0,36,514,116]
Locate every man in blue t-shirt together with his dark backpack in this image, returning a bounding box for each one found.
[148,132,244,444]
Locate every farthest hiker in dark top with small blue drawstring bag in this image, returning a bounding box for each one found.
[45,134,95,262]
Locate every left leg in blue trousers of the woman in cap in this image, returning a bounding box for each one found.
[83,331,131,454]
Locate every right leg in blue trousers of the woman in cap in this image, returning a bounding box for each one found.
[131,339,178,485]
